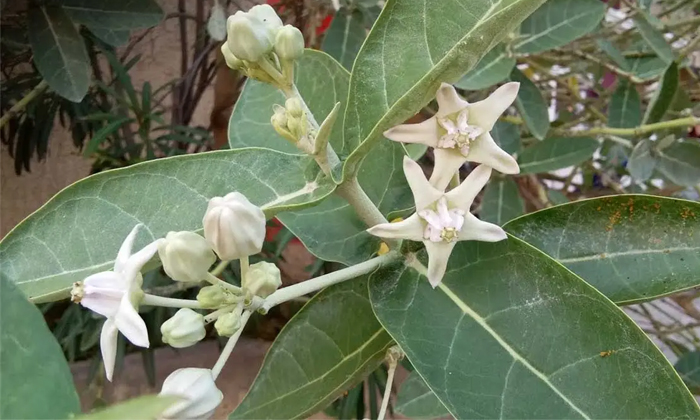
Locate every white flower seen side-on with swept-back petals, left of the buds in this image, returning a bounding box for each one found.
[71,224,159,381]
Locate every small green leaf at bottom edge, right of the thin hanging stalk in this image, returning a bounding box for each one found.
[395,372,450,419]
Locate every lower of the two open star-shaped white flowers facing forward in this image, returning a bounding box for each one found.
[367,157,506,287]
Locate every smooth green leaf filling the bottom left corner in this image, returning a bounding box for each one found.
[0,278,80,419]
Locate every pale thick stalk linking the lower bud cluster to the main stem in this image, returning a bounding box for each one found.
[260,252,400,312]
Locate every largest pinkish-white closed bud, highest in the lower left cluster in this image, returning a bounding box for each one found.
[202,192,265,261]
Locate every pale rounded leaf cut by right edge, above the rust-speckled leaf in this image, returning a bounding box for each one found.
[657,139,700,187]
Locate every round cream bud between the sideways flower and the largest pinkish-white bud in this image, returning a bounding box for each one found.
[158,231,216,282]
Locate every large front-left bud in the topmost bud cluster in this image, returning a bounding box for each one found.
[226,11,279,61]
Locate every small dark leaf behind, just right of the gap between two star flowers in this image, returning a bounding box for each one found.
[479,177,525,226]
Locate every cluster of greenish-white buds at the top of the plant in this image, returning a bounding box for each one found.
[221,4,304,87]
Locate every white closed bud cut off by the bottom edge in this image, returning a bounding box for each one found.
[158,368,224,419]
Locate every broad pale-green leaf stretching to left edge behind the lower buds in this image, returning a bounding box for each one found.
[0,148,334,301]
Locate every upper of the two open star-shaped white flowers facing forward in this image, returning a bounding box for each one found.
[384,82,520,190]
